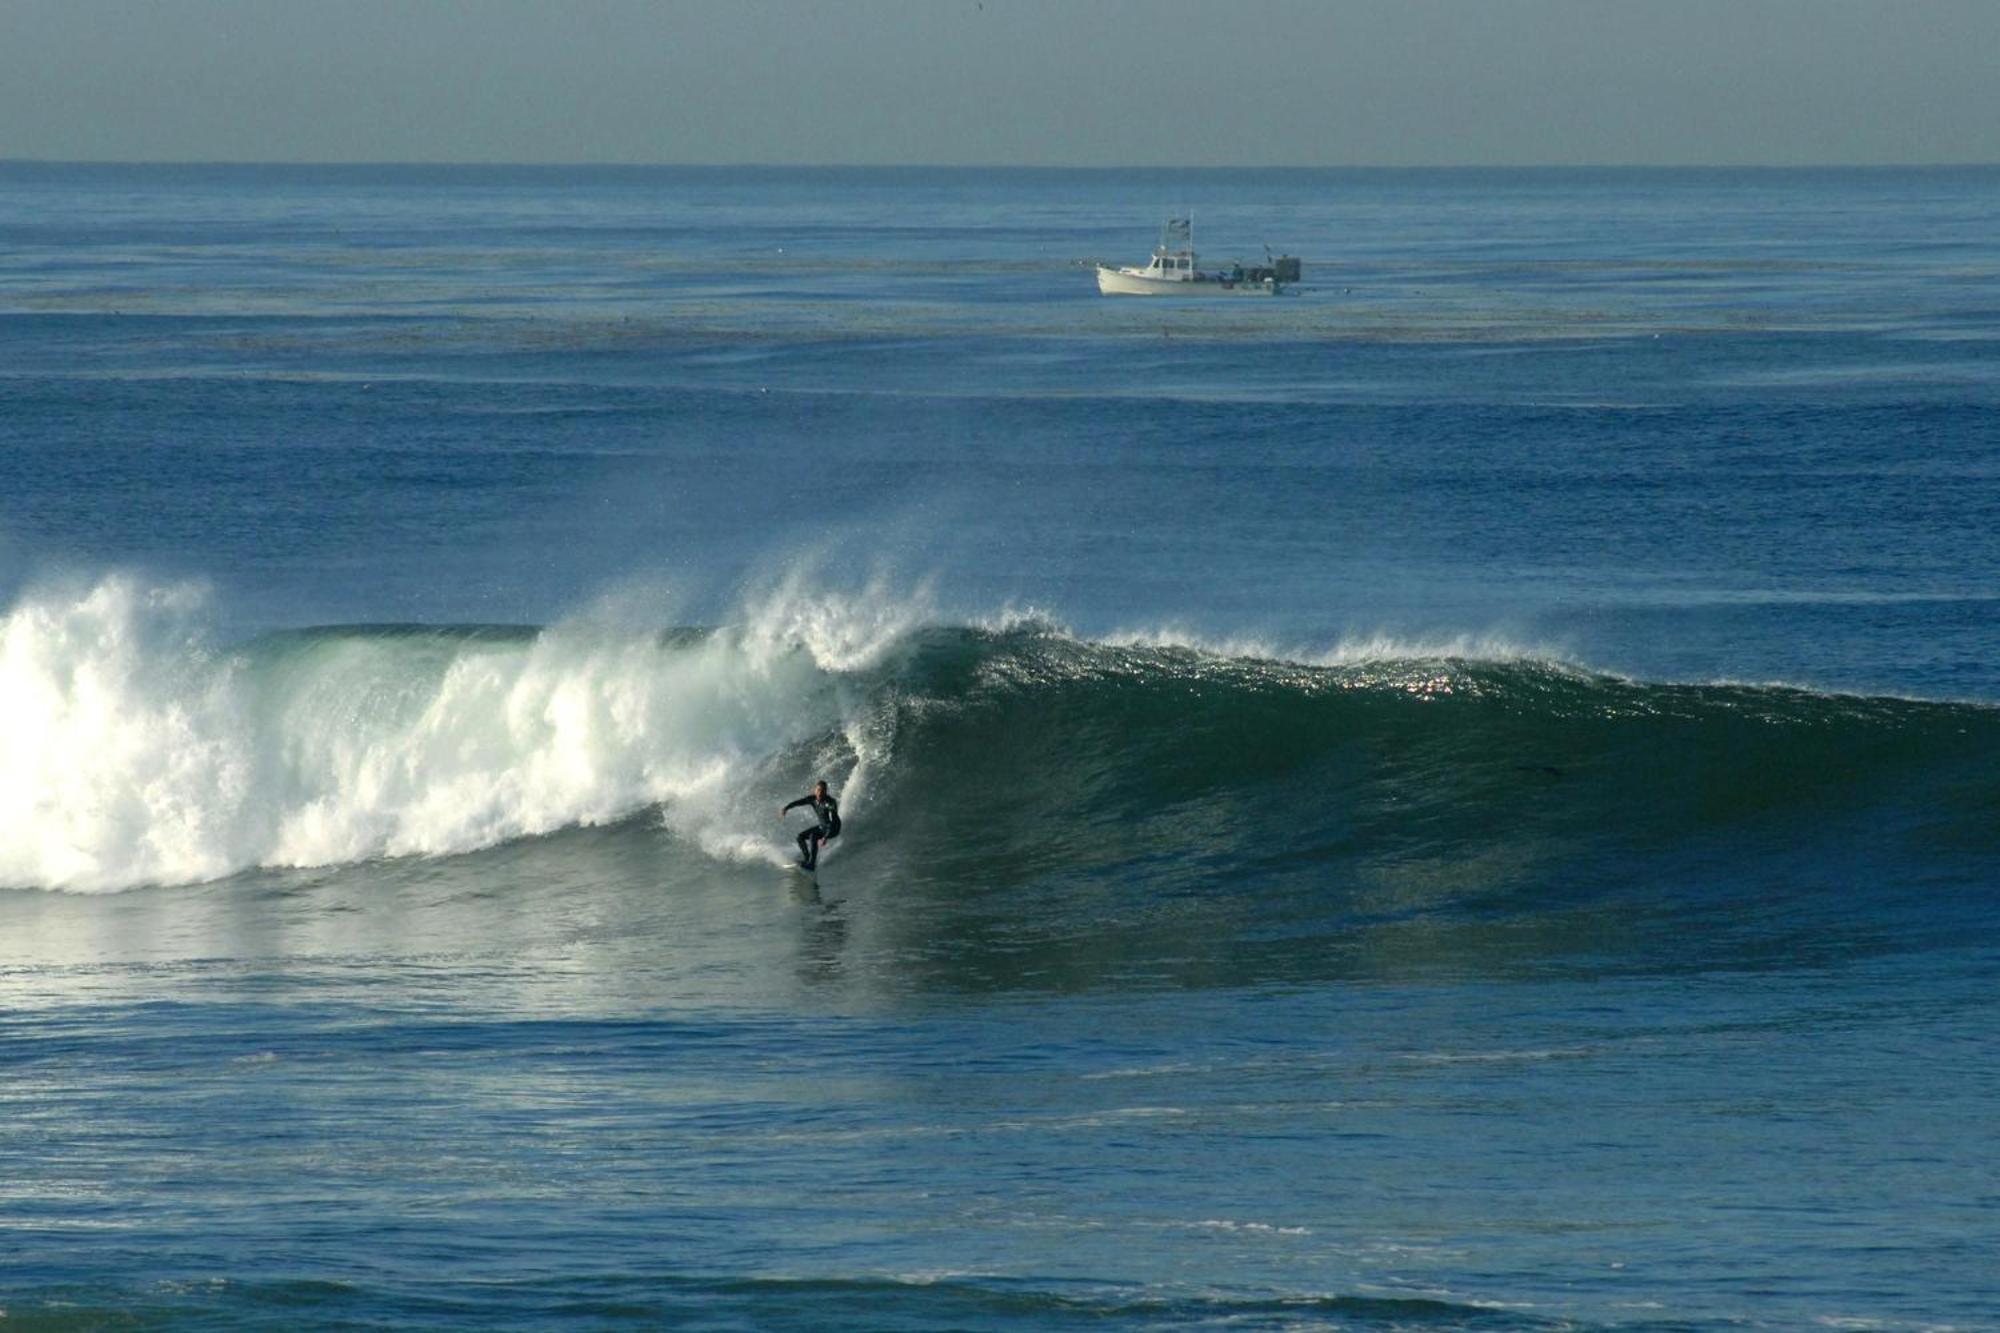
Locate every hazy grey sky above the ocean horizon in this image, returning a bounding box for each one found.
[0,0,2000,166]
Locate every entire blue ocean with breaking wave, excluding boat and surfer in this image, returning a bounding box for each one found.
[0,162,2000,1331]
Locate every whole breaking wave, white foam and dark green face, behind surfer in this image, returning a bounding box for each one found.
[0,578,2000,905]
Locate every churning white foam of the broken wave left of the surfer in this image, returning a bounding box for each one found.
[0,576,892,891]
